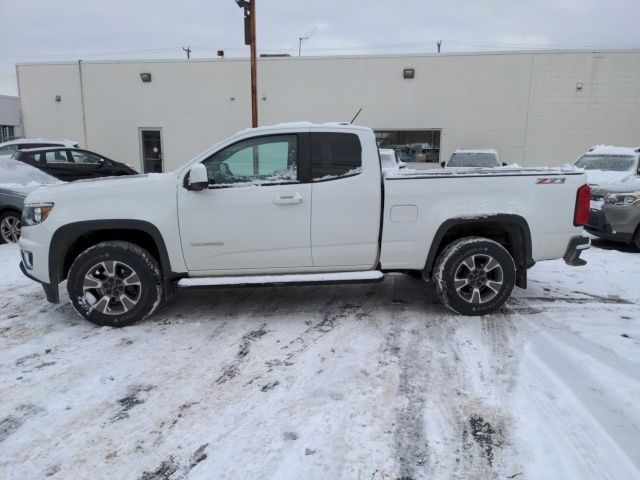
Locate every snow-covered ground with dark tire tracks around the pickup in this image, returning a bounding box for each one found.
[0,245,640,480]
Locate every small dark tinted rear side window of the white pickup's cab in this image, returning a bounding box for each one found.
[311,133,362,182]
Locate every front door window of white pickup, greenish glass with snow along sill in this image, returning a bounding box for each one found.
[202,135,298,186]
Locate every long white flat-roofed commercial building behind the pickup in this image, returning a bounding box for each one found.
[17,50,640,171]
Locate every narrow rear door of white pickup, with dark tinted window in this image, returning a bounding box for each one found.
[310,130,382,270]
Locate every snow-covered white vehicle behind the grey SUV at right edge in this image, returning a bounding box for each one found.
[574,145,640,185]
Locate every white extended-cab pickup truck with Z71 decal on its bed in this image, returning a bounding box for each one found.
[20,123,589,326]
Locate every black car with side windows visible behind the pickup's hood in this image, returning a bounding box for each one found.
[12,147,138,182]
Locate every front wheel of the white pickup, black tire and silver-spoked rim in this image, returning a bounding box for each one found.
[67,241,162,327]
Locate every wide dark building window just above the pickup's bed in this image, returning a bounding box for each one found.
[375,130,441,163]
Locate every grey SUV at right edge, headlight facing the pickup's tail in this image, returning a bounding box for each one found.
[585,176,640,249]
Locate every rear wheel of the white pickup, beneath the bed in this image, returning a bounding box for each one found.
[433,237,516,315]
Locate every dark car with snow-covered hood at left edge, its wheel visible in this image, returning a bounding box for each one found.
[0,158,59,244]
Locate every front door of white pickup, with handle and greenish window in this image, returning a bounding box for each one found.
[178,134,312,273]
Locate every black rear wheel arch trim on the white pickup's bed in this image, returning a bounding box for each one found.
[423,214,535,288]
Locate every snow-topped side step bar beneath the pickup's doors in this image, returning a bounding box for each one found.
[178,270,384,288]
